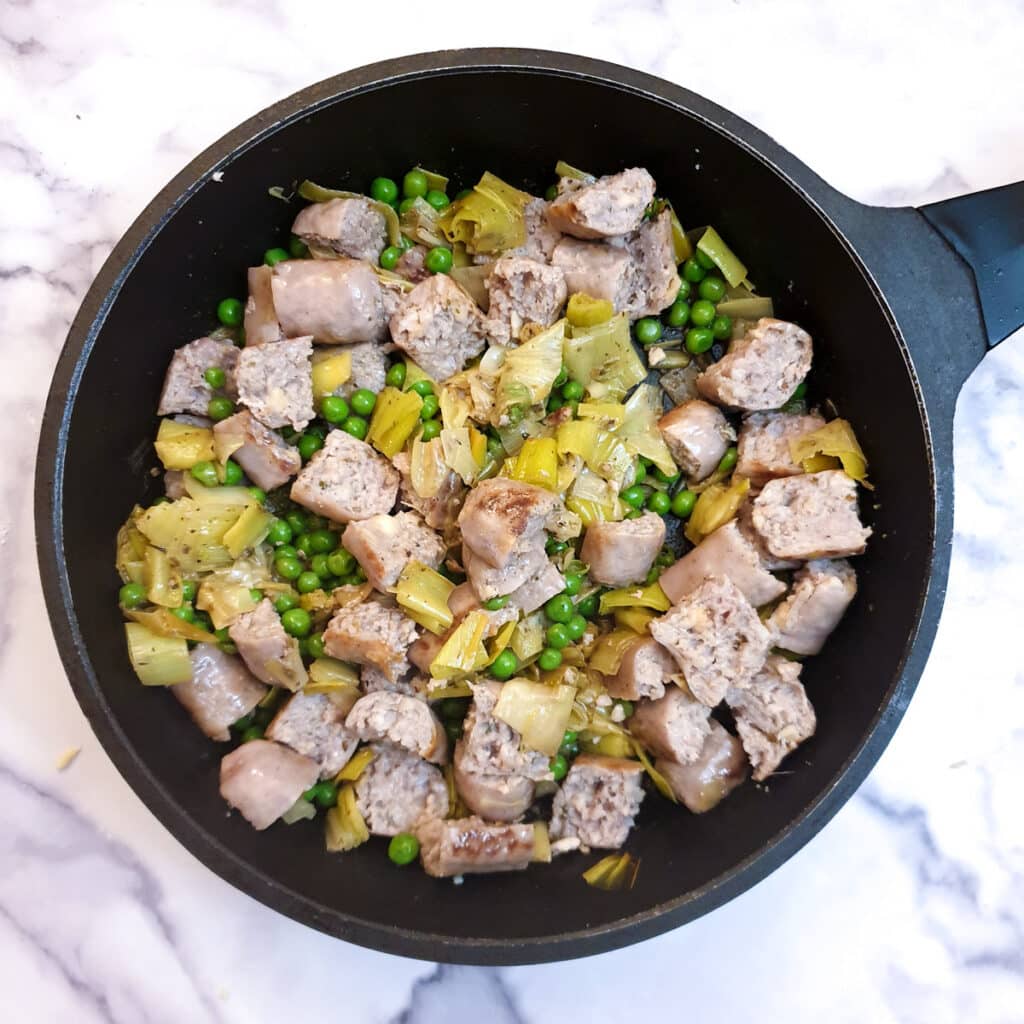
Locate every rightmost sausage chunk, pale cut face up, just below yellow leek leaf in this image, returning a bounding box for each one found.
[752,469,871,559]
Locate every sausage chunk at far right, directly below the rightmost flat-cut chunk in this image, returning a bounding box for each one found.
[768,560,857,654]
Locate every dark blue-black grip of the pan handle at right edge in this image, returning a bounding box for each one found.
[921,181,1024,348]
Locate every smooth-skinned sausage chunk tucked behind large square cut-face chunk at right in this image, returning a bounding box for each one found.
[657,519,785,608]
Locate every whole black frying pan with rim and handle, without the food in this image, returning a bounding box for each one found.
[36,49,1024,964]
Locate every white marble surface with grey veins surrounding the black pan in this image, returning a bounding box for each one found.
[0,0,1024,1024]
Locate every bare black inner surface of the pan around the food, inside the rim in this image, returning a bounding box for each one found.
[60,72,932,957]
